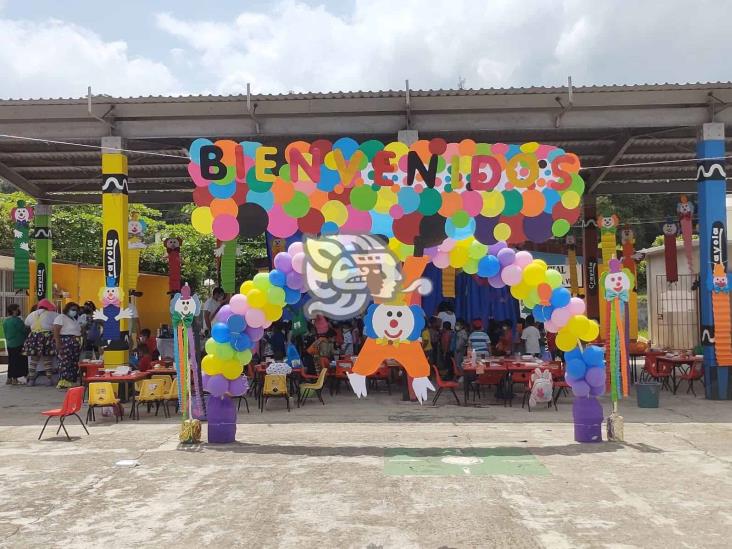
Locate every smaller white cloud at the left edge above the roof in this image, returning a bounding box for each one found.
[0,18,180,98]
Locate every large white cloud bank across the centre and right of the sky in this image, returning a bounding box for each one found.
[157,0,732,93]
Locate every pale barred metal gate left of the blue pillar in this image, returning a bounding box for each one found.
[651,274,699,349]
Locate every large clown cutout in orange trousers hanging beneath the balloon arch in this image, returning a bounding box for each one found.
[348,257,435,404]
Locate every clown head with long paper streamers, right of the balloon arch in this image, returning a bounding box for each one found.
[600,259,634,402]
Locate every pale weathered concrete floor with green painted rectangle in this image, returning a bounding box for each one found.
[0,376,732,549]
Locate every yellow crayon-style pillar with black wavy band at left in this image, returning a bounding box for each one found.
[100,137,131,366]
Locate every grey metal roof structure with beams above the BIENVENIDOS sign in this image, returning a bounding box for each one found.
[0,82,732,204]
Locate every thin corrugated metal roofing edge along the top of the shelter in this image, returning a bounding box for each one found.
[0,82,732,105]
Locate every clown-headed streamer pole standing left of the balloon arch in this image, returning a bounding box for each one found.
[170,284,204,442]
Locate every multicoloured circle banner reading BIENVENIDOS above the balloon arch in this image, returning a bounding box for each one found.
[188,137,585,255]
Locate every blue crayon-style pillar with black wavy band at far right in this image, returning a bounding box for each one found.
[697,123,732,400]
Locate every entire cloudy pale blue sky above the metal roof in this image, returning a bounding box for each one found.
[0,0,732,98]
